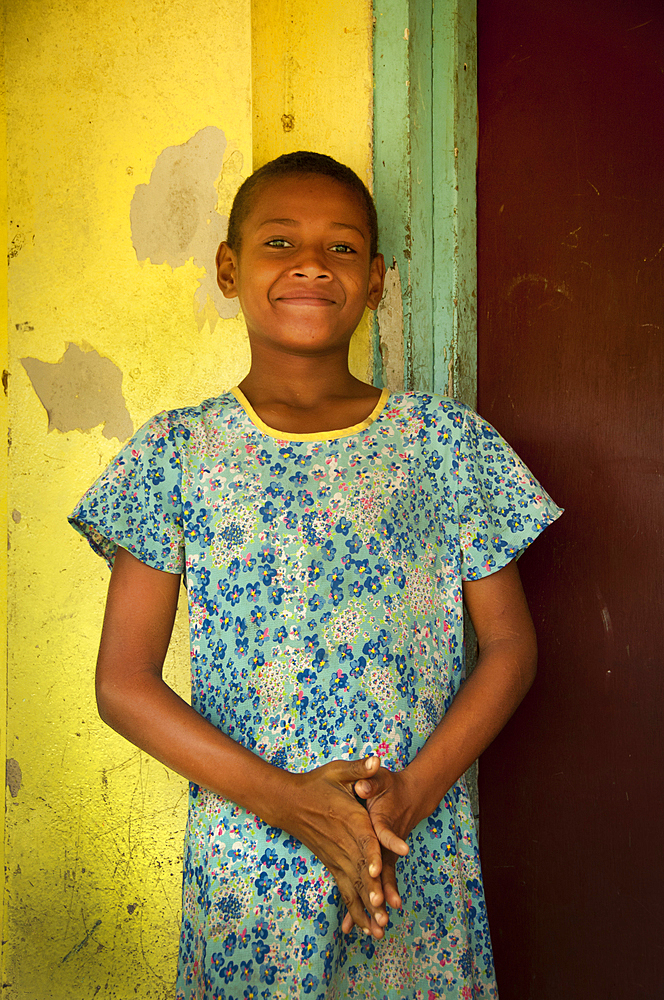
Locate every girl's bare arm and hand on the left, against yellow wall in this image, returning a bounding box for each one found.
[96,548,396,937]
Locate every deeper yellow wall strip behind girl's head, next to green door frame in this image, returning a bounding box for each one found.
[251,0,373,382]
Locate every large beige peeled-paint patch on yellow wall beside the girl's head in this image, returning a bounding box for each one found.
[129,125,242,330]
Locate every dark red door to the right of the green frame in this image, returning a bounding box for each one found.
[478,0,664,1000]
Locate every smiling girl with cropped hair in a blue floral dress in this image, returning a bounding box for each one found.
[71,153,560,1000]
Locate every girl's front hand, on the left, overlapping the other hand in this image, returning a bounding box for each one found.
[279,757,392,938]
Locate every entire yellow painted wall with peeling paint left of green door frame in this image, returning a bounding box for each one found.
[0,0,371,1000]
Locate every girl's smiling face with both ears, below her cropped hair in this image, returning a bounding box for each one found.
[217,174,385,355]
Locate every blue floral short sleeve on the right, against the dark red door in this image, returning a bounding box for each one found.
[454,408,562,580]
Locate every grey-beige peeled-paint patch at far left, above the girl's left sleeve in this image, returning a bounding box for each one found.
[21,344,134,441]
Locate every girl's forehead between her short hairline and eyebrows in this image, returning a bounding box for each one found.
[245,174,369,239]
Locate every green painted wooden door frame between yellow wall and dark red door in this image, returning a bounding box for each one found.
[374,0,477,406]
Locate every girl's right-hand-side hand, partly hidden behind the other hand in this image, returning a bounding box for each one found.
[341,767,416,933]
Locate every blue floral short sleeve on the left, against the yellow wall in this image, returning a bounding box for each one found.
[69,413,184,573]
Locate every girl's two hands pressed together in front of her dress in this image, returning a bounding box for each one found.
[282,757,417,939]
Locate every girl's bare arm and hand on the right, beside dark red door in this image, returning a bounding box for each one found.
[346,562,537,927]
